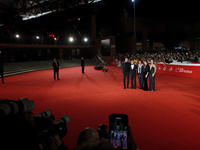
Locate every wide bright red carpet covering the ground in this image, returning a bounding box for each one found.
[0,66,200,150]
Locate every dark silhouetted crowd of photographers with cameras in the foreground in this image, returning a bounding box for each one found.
[0,98,137,150]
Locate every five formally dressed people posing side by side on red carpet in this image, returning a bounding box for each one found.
[122,58,156,92]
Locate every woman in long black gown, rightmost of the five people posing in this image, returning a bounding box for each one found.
[149,59,156,92]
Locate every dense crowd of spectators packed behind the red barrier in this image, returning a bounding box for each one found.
[114,51,200,63]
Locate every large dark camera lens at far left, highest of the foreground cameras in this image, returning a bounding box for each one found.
[0,98,35,115]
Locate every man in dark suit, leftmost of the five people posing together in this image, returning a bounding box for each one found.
[122,58,131,89]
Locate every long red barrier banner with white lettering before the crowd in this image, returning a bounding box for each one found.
[156,64,200,78]
